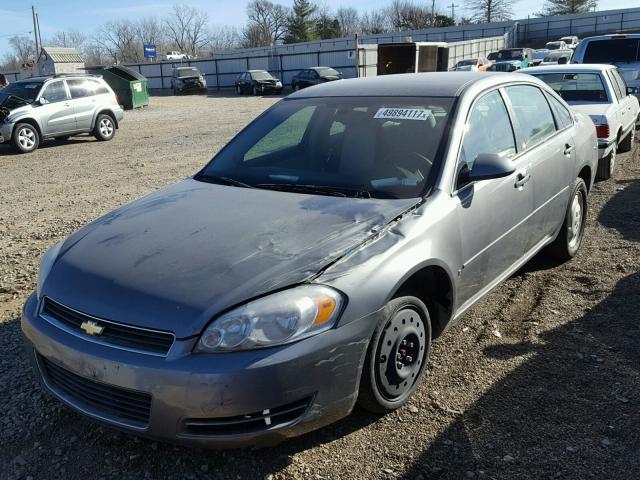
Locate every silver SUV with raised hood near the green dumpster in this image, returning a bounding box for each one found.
[0,74,124,153]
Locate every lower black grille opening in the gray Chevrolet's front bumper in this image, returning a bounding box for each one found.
[38,355,151,428]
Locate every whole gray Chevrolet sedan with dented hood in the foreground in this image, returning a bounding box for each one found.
[22,72,597,447]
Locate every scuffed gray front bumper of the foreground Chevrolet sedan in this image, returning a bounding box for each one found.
[21,294,376,448]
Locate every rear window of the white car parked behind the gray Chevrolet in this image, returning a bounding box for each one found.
[534,73,609,103]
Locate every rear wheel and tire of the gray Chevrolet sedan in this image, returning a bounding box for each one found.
[548,178,588,262]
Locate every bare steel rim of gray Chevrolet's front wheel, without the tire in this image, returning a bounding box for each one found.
[375,308,427,401]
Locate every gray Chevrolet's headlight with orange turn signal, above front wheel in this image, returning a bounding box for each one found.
[195,285,344,352]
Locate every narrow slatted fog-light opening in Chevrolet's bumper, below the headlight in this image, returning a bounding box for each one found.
[184,397,312,436]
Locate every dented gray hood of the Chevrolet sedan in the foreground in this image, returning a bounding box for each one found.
[41,179,418,338]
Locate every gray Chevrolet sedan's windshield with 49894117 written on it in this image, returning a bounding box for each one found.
[195,97,454,198]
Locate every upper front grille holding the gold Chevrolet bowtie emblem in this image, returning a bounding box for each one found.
[42,298,174,355]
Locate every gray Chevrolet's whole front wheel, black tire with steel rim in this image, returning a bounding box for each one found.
[358,296,431,413]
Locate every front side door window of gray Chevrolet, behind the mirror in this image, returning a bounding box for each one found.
[460,90,516,170]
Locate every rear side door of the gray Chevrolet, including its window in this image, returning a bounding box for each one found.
[505,85,575,246]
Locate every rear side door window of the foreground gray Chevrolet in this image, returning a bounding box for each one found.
[505,85,556,149]
